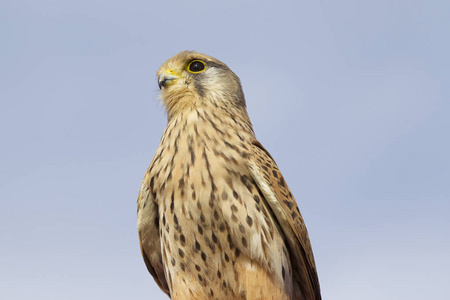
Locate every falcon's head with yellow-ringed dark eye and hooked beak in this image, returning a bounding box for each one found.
[156,51,245,118]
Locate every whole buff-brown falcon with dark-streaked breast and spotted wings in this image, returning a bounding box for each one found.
[137,51,321,300]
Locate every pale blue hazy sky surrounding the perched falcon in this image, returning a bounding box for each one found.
[0,0,450,300]
